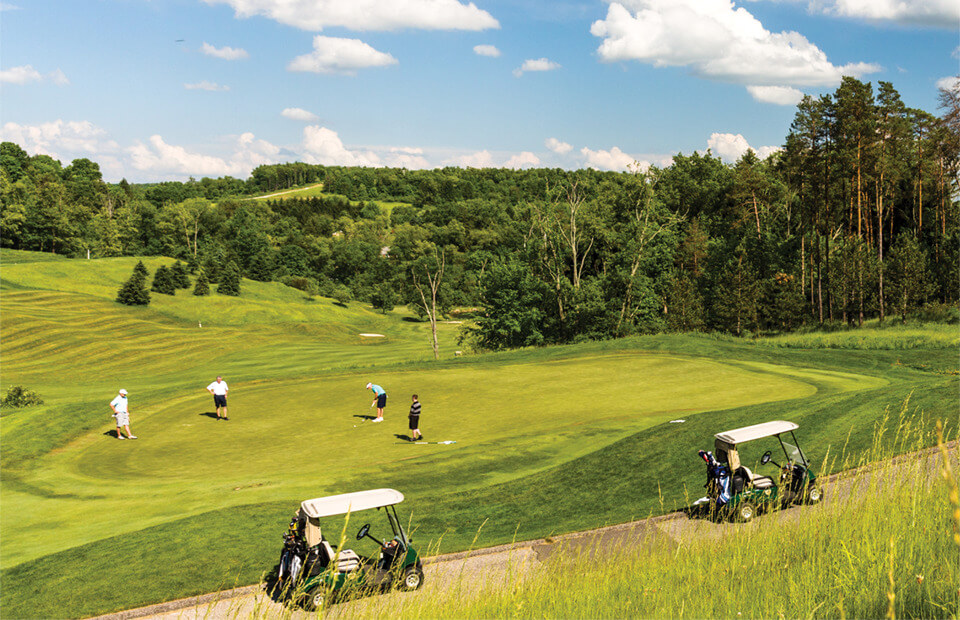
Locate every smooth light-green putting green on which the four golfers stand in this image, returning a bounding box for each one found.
[0,353,816,566]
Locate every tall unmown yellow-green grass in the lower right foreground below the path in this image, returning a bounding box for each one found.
[324,405,960,618]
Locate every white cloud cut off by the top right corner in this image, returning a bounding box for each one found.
[809,0,960,29]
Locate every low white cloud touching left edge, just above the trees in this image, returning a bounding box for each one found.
[0,119,119,160]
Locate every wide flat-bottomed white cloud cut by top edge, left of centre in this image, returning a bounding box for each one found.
[205,0,500,31]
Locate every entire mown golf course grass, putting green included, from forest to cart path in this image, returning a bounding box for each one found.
[0,251,957,616]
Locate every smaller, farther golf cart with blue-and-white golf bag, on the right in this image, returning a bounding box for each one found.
[698,421,823,522]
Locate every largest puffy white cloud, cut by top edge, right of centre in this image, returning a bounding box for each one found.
[590,0,880,97]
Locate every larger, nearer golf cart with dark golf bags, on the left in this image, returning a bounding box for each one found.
[273,489,423,611]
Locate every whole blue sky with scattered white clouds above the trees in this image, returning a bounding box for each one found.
[0,0,960,182]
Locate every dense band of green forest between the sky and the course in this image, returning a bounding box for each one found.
[0,78,960,349]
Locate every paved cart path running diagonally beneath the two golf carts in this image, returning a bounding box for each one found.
[98,441,958,620]
